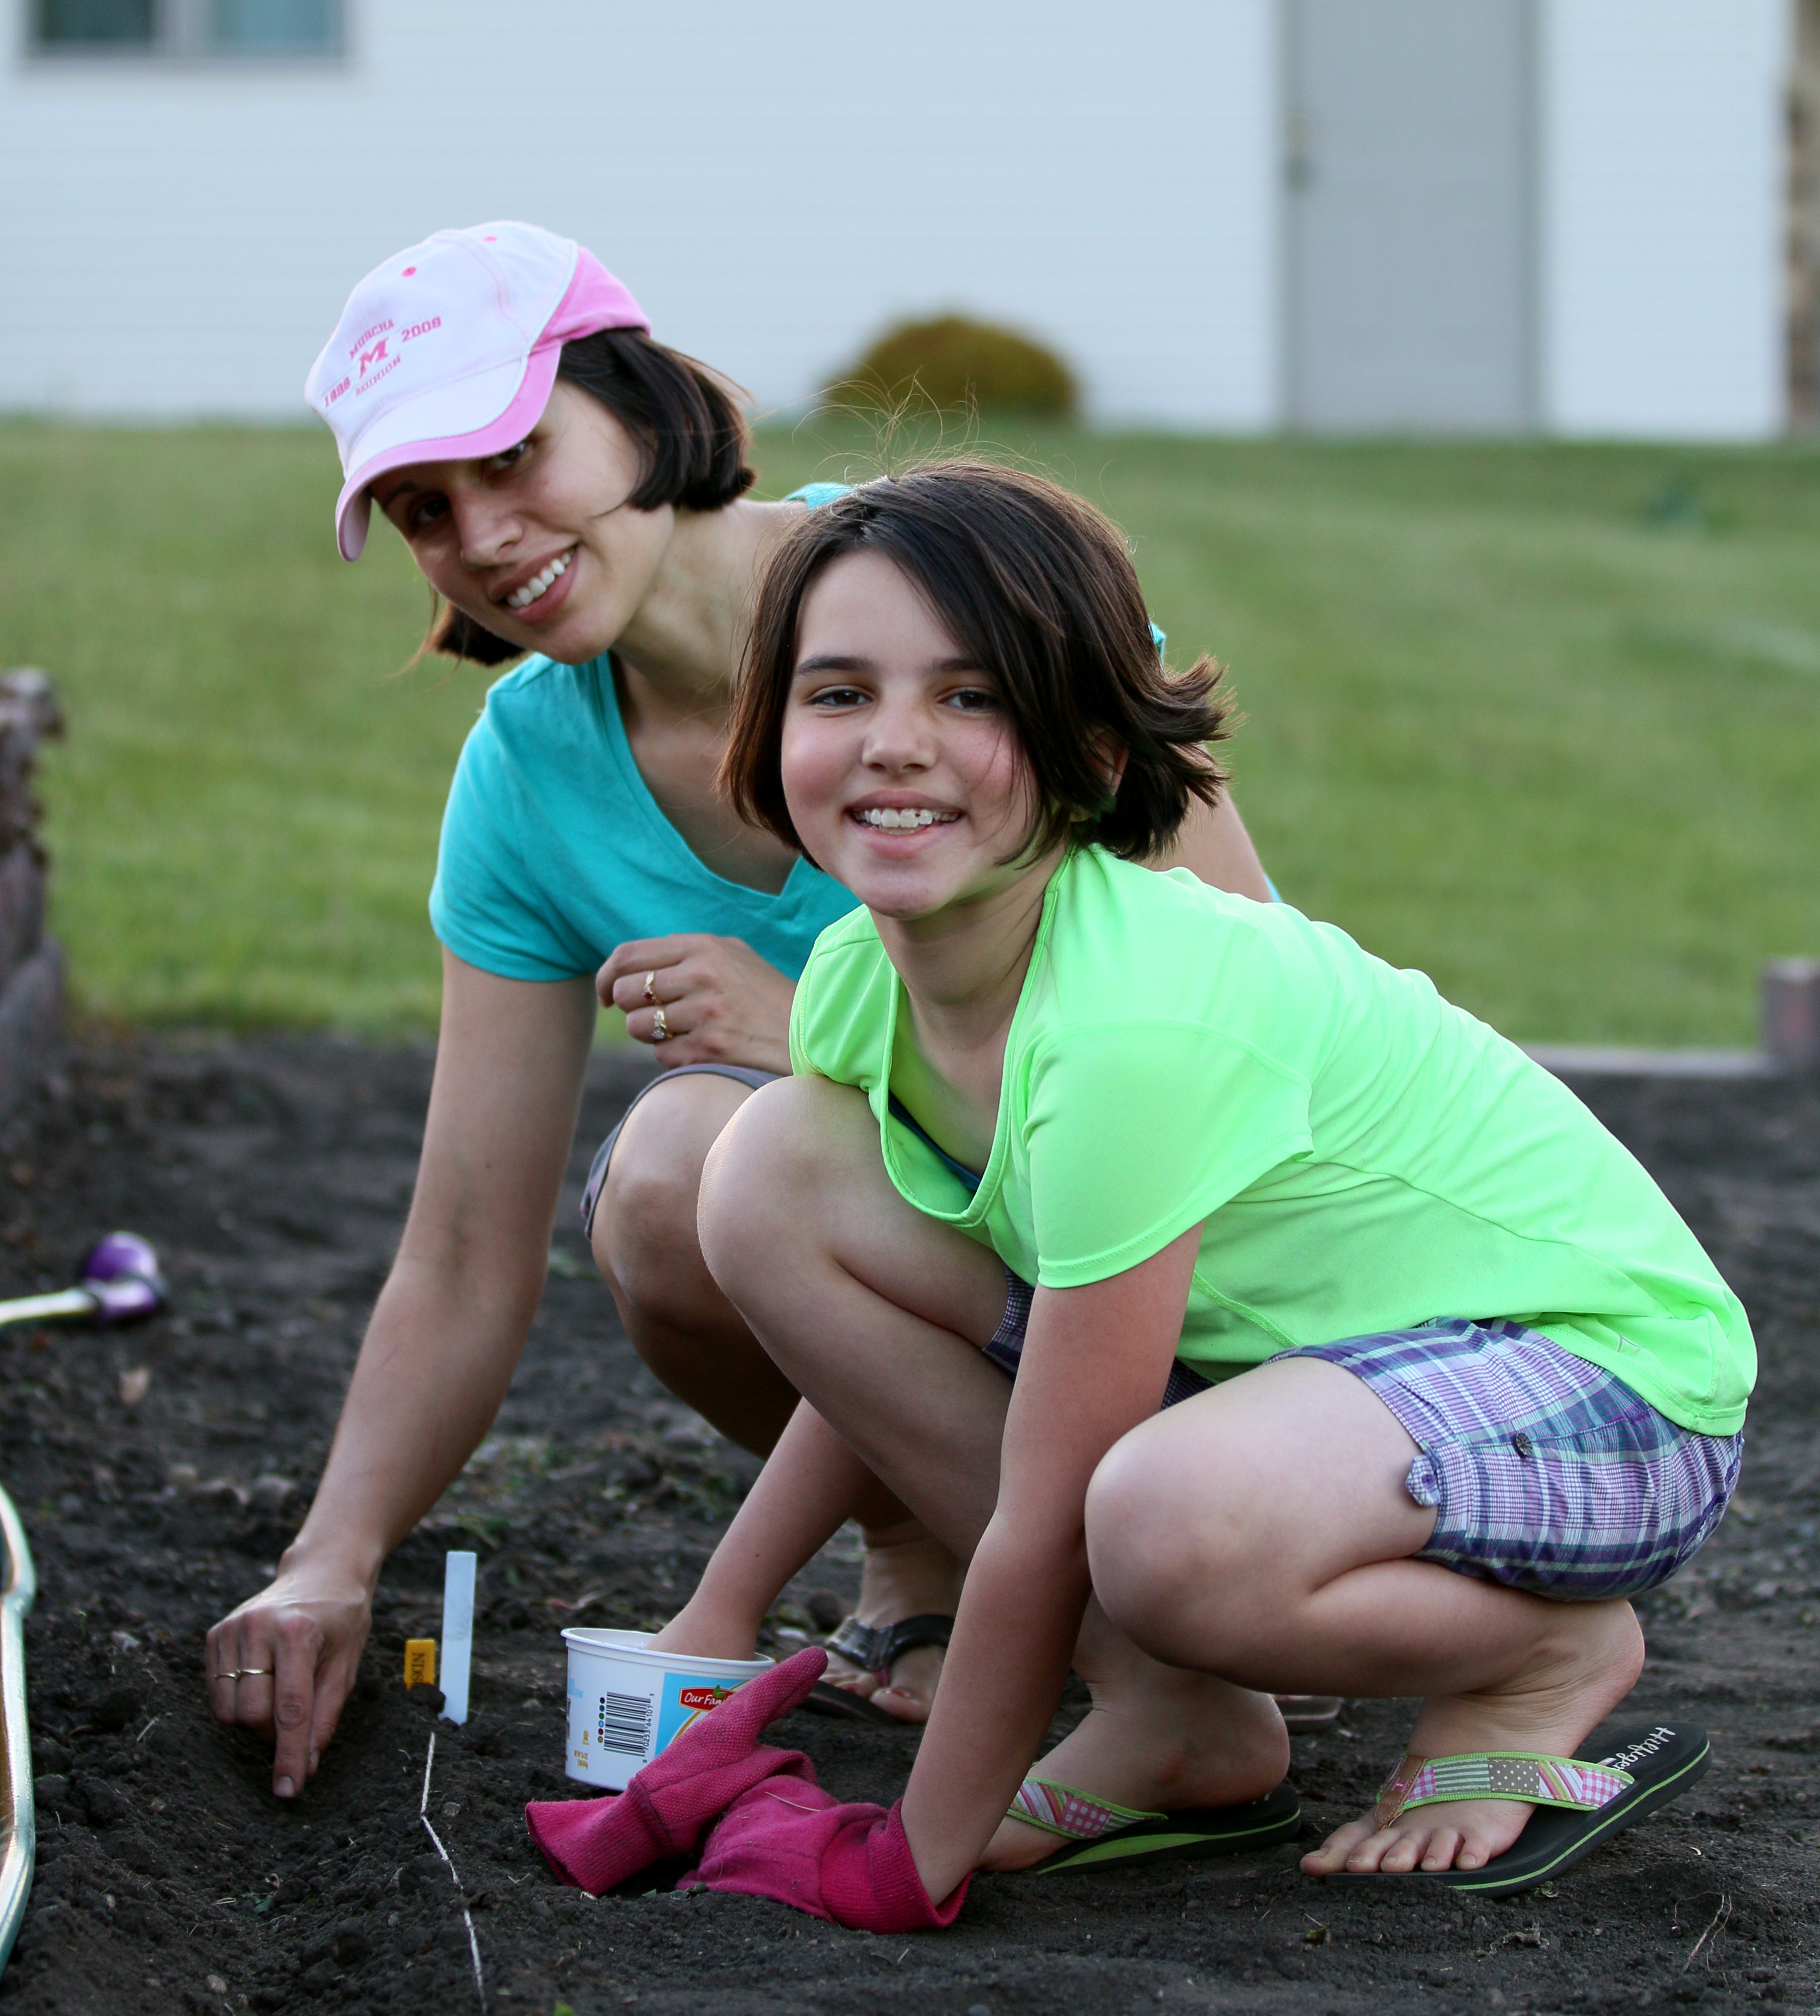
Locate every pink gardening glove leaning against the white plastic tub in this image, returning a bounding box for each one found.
[524,1645,828,1897]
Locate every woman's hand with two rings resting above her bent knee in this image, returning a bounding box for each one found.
[595,931,796,1076]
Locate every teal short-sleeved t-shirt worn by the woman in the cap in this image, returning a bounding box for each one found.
[429,484,853,980]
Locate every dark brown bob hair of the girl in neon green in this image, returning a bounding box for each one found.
[719,462,1233,861]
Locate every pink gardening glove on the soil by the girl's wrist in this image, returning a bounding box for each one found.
[693,1760,973,1931]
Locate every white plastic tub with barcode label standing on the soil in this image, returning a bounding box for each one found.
[562,1627,776,1792]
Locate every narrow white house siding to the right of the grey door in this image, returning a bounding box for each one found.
[1540,0,1790,440]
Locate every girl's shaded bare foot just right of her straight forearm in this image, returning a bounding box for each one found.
[979,1661,1290,1869]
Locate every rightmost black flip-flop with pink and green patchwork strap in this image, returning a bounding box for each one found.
[1324,1722,1713,1895]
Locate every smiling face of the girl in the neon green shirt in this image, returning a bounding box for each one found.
[780,552,1036,919]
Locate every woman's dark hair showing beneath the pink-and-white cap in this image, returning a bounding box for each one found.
[423,329,758,665]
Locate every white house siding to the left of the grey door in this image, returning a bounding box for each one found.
[0,0,1278,427]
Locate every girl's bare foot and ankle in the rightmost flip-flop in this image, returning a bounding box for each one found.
[1302,1603,1642,1877]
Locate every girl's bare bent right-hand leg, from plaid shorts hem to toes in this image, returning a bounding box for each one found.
[1080,1359,1642,1875]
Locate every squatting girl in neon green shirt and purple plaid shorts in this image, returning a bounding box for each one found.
[613,466,1754,1907]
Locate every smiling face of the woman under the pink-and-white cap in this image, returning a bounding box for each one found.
[373,379,675,665]
